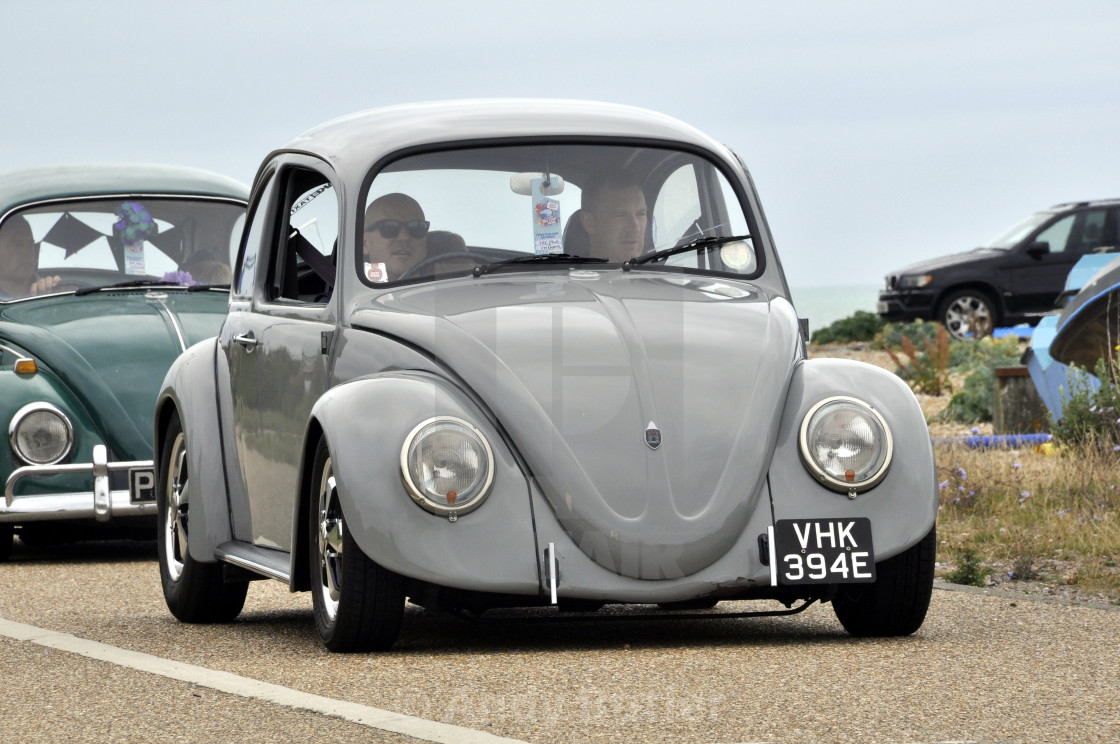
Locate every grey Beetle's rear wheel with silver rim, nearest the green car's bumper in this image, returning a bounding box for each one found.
[156,413,249,623]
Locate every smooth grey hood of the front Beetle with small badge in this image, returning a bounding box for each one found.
[352,271,802,579]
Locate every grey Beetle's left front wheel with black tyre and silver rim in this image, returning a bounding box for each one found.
[308,439,404,652]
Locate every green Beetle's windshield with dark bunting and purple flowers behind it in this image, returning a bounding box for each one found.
[0,197,245,301]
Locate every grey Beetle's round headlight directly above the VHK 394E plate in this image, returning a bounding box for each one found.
[801,396,894,493]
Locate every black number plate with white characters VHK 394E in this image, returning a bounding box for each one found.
[774,517,875,585]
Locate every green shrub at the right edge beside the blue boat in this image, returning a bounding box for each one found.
[1053,359,1120,450]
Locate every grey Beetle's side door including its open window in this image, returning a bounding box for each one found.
[222,156,338,550]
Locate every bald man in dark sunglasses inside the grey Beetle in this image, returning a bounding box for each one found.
[362,194,429,281]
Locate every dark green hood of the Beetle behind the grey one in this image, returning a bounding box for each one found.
[0,290,228,459]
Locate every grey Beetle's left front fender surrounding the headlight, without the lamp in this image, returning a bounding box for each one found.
[311,372,540,595]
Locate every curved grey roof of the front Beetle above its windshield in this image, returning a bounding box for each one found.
[282,99,731,178]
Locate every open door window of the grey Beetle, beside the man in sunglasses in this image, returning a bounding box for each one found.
[269,168,338,304]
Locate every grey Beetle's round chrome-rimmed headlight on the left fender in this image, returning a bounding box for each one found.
[401,417,494,514]
